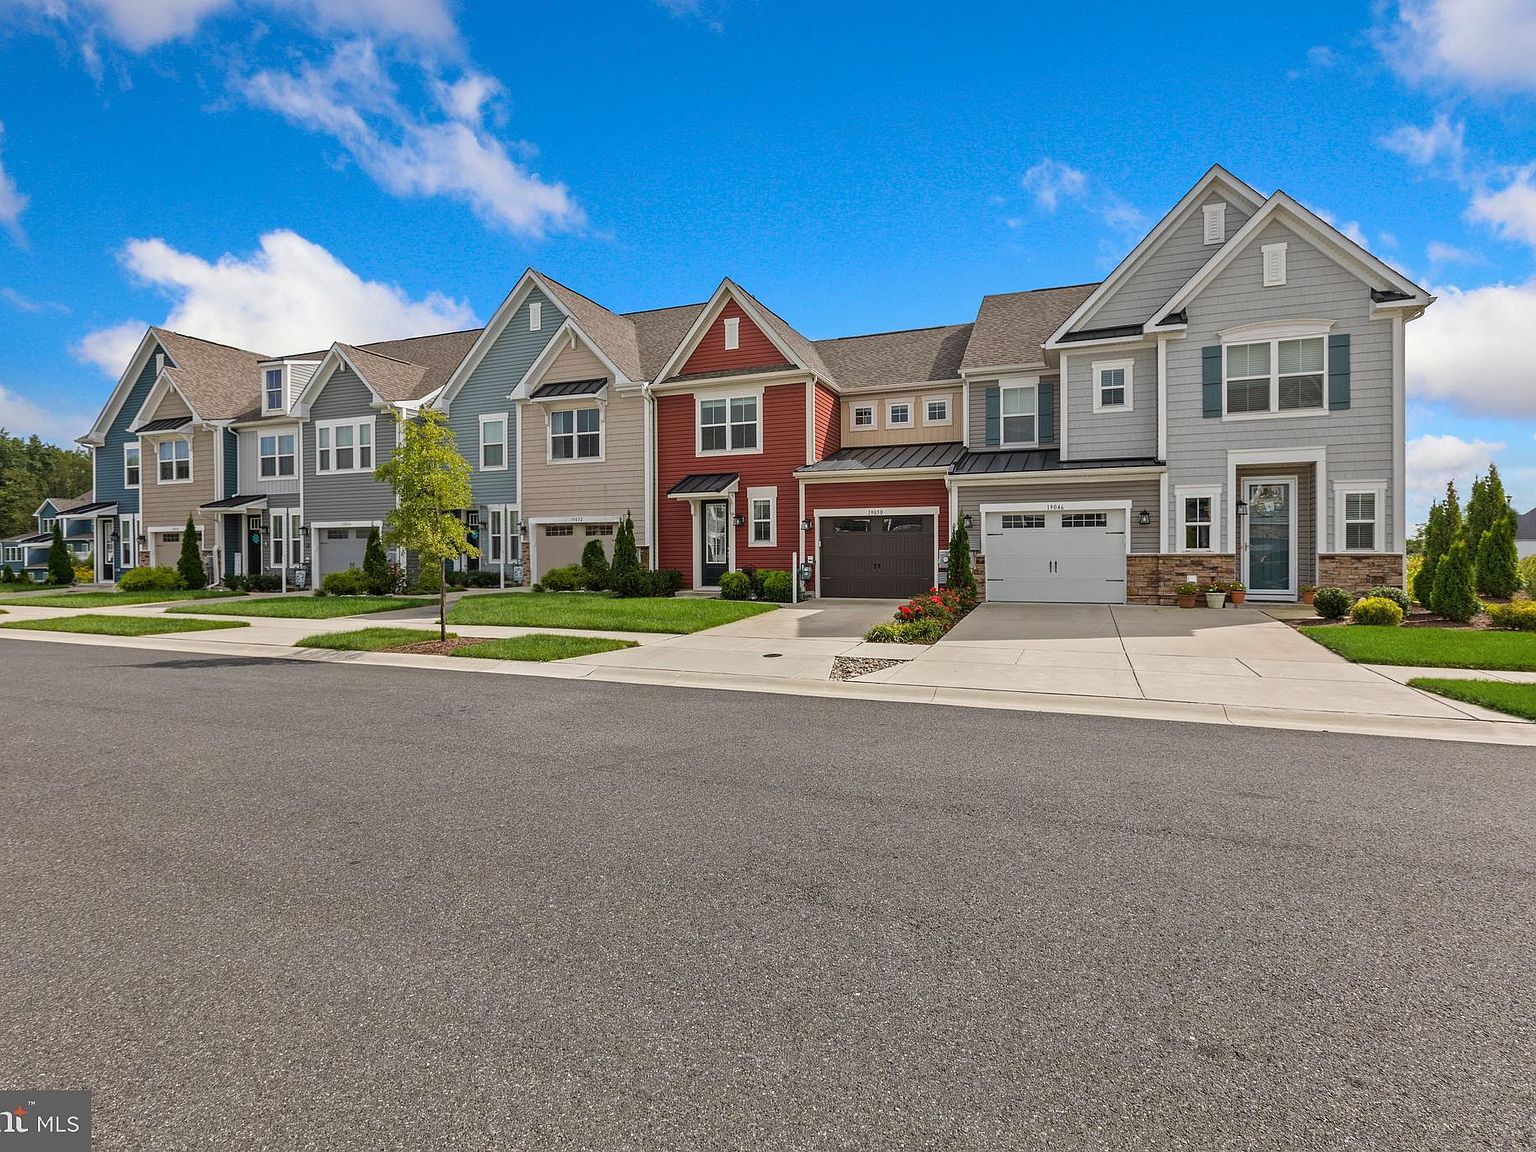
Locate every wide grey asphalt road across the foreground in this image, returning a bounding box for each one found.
[0,639,1536,1152]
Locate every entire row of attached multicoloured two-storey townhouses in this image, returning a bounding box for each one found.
[38,167,1432,602]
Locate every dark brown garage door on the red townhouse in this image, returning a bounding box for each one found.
[817,516,938,599]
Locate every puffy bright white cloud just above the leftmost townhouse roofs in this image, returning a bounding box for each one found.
[75,232,478,376]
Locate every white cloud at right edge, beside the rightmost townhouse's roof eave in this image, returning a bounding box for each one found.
[1407,280,1536,419]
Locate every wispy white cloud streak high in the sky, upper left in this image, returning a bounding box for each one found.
[243,40,585,237]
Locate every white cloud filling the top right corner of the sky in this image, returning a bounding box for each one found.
[1376,0,1536,92]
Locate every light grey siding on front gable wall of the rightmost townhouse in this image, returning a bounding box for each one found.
[1167,221,1398,551]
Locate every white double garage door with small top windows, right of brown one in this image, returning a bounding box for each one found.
[986,508,1126,604]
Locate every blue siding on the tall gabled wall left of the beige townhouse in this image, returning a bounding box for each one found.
[449,287,565,505]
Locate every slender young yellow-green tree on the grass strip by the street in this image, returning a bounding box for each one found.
[373,409,479,641]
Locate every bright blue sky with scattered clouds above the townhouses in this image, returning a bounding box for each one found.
[0,0,1536,515]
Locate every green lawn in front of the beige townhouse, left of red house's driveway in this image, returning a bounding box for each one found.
[449,591,776,633]
